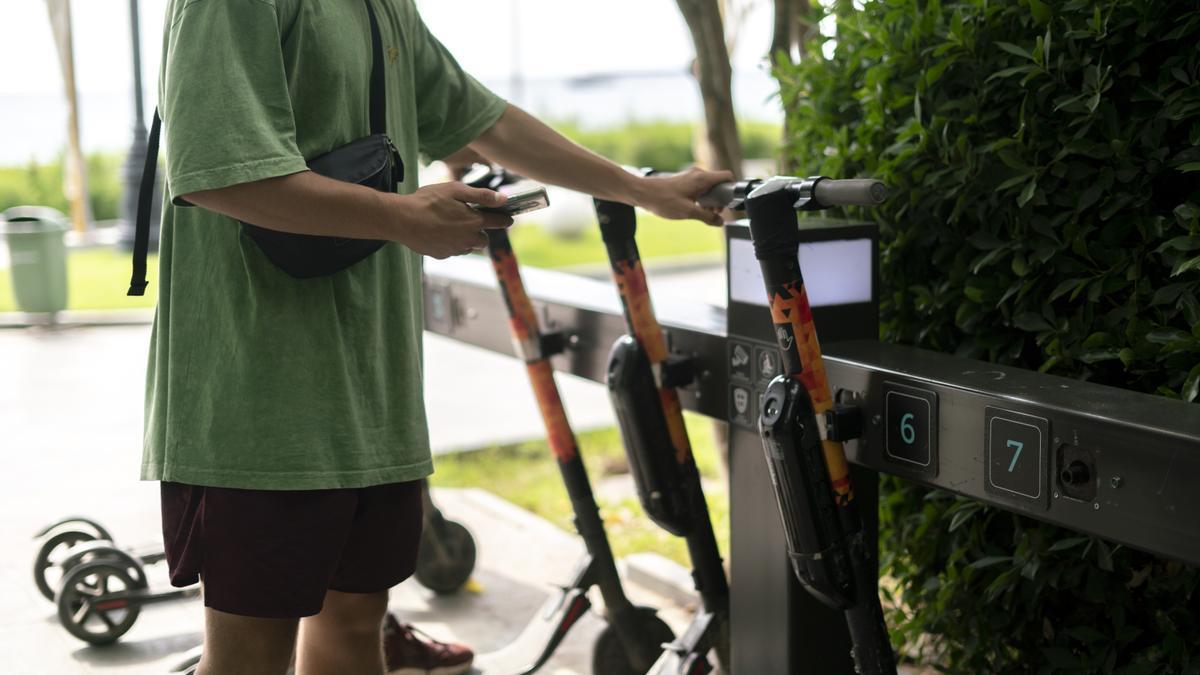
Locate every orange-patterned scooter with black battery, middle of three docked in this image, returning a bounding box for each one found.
[595,199,730,675]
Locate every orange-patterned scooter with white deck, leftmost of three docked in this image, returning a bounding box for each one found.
[464,168,674,675]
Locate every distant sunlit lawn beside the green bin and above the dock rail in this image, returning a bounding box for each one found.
[0,215,724,312]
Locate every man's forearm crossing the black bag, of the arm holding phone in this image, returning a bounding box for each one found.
[184,172,400,239]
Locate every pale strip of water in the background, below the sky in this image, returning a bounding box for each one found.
[0,70,782,166]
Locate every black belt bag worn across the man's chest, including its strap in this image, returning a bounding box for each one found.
[128,0,404,295]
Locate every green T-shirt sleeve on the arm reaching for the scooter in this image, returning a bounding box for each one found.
[410,8,508,160]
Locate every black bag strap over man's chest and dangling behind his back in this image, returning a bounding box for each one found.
[126,0,388,295]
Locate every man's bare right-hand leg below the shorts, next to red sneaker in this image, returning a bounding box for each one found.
[296,590,388,675]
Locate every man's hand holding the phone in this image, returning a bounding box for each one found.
[396,183,512,259]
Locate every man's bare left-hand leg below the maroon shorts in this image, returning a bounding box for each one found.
[197,608,297,675]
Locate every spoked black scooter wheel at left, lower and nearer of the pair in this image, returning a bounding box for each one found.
[55,558,142,645]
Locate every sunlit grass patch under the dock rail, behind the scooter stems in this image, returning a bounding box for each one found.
[431,413,730,567]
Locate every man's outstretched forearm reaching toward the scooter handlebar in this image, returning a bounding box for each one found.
[470,106,642,204]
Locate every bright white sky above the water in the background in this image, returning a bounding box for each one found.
[0,0,770,97]
